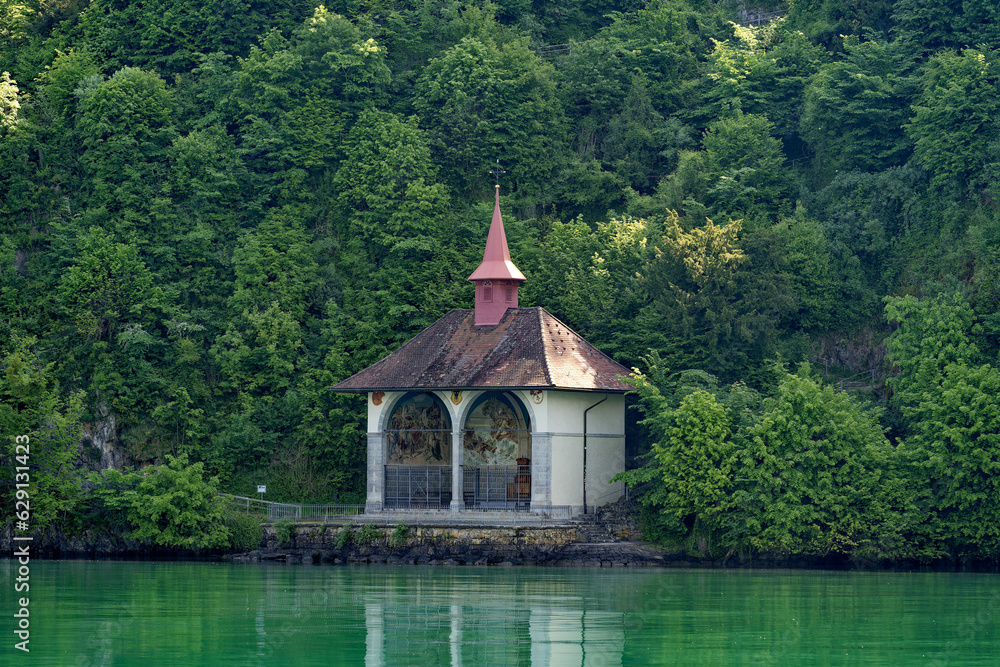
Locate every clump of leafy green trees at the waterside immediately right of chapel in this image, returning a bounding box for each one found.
[622,366,923,560]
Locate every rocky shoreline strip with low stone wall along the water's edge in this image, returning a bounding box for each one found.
[0,503,998,573]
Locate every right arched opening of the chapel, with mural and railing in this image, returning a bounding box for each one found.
[462,391,531,509]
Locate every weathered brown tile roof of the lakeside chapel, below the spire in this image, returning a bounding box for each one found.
[331,308,630,392]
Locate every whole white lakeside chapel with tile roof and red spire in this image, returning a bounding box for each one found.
[333,189,628,518]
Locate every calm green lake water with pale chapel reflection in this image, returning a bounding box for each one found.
[0,561,1000,667]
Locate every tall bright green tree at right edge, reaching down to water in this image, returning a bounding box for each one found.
[885,294,1000,558]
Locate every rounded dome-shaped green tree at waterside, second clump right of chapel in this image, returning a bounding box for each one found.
[724,368,908,559]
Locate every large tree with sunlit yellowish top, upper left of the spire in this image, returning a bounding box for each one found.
[219,6,390,197]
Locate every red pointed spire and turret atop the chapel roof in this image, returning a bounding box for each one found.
[469,185,525,326]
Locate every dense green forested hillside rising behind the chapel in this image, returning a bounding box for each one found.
[0,0,1000,559]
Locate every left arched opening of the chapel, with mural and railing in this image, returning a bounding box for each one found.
[385,392,452,508]
